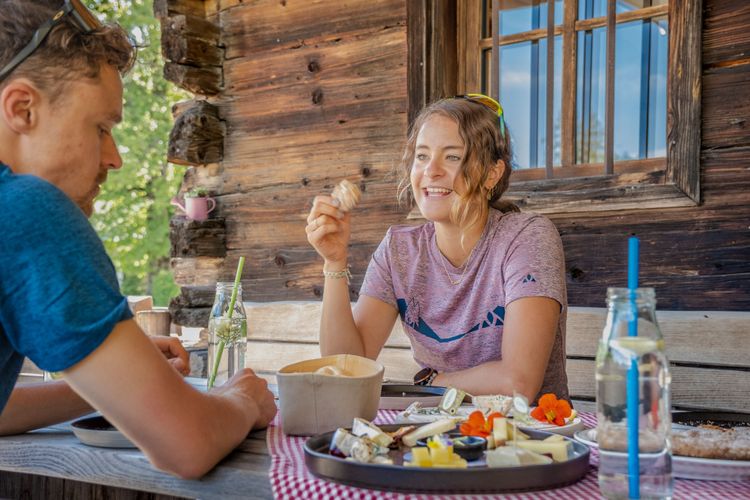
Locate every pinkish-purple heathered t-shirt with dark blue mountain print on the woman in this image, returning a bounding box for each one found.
[360,209,568,399]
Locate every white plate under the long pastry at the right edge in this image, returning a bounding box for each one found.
[574,429,750,481]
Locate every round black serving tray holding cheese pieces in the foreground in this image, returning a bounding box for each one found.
[304,425,589,493]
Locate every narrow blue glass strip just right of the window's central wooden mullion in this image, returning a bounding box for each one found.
[576,28,617,163]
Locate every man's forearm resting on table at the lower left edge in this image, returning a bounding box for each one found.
[0,381,93,436]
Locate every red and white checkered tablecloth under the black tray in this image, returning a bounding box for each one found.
[267,410,750,500]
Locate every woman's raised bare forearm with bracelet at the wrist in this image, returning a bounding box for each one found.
[320,263,365,356]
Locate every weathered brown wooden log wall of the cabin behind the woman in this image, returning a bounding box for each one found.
[164,0,750,326]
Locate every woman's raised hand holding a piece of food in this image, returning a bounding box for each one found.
[305,195,351,270]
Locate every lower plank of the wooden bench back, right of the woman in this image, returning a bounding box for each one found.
[566,359,750,413]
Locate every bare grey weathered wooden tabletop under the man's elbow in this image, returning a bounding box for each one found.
[0,423,273,498]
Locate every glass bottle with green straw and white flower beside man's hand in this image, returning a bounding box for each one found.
[207,282,247,389]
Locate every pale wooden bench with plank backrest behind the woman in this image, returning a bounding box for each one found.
[245,302,750,413]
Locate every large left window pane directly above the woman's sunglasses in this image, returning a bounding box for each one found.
[500,36,562,168]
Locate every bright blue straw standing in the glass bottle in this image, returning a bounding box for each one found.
[627,237,641,498]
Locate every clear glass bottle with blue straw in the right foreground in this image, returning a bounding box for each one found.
[596,288,673,498]
